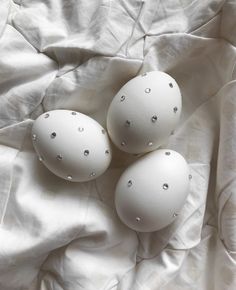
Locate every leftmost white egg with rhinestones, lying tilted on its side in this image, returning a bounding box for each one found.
[32,110,112,182]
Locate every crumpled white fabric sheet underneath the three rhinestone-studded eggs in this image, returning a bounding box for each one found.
[0,0,236,290]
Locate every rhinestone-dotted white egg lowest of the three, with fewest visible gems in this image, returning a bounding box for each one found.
[115,149,191,232]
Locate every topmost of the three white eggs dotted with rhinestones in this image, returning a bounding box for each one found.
[107,71,182,153]
